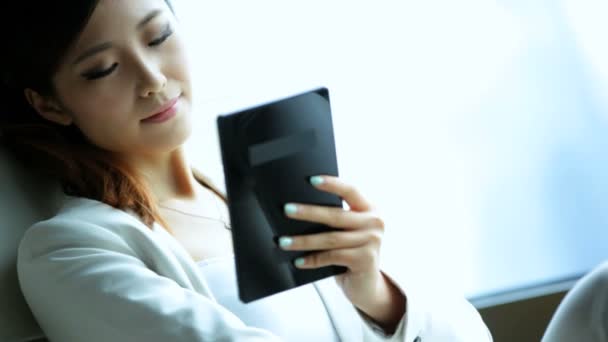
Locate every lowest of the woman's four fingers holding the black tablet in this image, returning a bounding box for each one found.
[294,246,379,272]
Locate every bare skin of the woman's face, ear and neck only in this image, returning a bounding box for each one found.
[25,0,196,202]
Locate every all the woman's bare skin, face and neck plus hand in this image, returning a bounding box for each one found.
[25,0,406,332]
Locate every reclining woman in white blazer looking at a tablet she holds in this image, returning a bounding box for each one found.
[0,0,491,342]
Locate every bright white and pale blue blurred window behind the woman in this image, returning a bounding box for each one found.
[171,0,608,341]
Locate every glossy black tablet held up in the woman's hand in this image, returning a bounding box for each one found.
[217,88,346,303]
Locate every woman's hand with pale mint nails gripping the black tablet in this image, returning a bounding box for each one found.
[279,176,405,330]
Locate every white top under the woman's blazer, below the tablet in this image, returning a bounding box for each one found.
[197,256,339,342]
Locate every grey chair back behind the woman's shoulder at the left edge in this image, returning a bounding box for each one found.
[0,146,64,342]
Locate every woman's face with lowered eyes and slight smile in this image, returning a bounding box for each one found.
[53,0,192,155]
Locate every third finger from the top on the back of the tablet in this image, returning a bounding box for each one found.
[279,230,382,251]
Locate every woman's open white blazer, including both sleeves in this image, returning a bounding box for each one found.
[17,196,492,342]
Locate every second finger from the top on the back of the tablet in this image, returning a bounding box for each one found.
[285,203,384,229]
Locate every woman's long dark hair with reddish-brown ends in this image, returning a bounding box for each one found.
[0,0,221,228]
